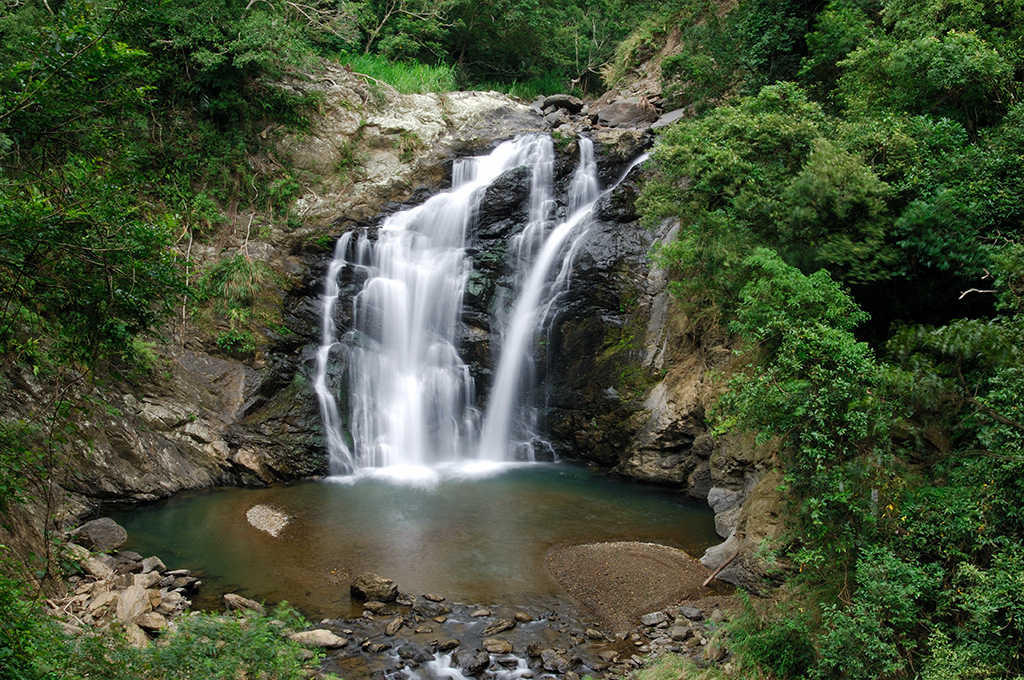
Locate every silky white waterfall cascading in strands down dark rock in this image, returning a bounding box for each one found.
[313,135,639,475]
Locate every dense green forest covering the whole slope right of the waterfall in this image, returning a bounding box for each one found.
[641,0,1024,678]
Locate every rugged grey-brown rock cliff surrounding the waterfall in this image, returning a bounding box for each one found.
[0,62,778,582]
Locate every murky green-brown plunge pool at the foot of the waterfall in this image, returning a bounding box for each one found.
[104,463,720,618]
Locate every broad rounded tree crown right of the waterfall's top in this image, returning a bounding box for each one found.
[638,83,894,309]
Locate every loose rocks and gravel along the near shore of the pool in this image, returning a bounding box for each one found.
[48,518,736,680]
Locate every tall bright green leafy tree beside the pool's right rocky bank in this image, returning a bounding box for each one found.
[717,249,889,570]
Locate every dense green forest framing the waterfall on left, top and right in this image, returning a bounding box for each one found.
[0,0,1024,679]
